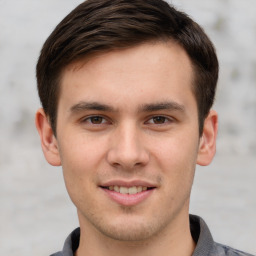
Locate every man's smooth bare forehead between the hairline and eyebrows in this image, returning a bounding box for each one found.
[60,41,196,110]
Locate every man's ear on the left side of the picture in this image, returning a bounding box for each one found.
[35,108,61,166]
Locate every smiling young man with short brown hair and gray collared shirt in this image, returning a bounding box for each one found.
[36,0,253,256]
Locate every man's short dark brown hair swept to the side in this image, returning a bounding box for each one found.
[36,0,219,135]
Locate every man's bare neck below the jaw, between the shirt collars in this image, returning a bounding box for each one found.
[75,215,195,256]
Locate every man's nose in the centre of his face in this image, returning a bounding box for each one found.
[107,125,149,170]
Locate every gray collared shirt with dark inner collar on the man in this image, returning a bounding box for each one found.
[51,215,253,256]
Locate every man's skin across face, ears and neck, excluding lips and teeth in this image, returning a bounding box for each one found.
[36,42,217,256]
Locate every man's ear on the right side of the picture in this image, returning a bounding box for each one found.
[197,110,218,165]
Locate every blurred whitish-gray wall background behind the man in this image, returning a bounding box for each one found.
[0,0,256,256]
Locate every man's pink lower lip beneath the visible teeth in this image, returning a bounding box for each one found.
[102,188,155,206]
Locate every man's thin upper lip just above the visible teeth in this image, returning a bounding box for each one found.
[99,180,157,188]
